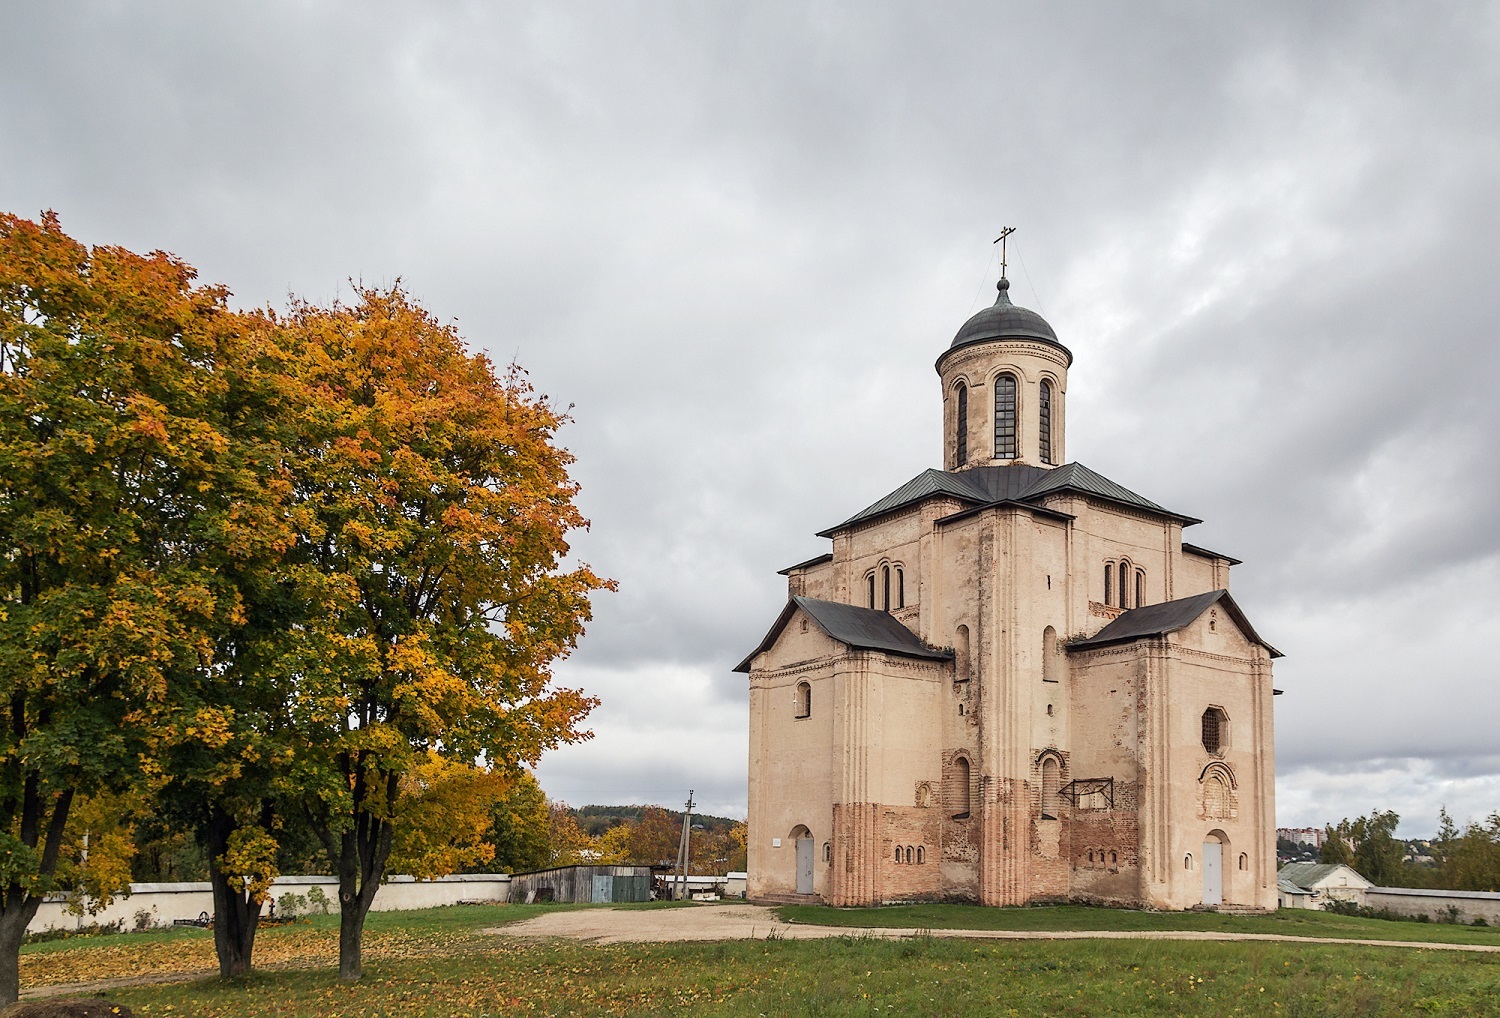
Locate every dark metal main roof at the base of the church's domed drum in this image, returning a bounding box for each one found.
[818,463,1203,537]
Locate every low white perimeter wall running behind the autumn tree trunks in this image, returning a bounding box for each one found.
[27,873,510,933]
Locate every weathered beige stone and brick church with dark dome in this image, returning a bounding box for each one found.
[737,272,1280,909]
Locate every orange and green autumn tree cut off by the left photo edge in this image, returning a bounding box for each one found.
[0,214,290,1003]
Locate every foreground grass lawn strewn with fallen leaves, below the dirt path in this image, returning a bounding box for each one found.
[20,906,1500,1018]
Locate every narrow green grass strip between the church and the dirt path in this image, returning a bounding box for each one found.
[777,904,1500,946]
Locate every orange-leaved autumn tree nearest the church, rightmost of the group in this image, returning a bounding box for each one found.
[278,286,614,981]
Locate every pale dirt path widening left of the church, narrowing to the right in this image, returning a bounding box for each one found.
[486,906,1500,954]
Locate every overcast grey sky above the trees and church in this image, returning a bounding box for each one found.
[0,0,1500,837]
